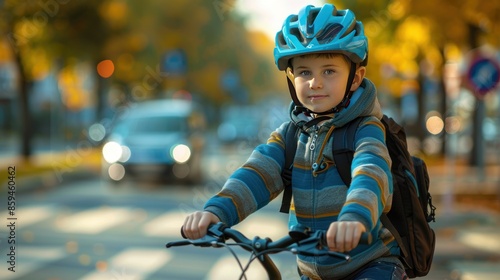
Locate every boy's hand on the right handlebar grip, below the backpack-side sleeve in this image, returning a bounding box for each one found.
[326,221,366,253]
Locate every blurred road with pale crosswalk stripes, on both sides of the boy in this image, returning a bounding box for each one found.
[0,143,500,280]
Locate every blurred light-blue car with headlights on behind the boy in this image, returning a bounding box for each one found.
[102,100,204,182]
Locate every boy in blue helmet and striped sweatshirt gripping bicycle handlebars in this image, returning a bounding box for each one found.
[183,4,407,279]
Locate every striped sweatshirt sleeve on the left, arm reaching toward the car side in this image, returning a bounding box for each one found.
[204,121,285,226]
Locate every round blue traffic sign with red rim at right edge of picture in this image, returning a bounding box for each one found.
[467,57,500,97]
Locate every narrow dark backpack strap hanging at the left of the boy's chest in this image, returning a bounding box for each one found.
[280,121,300,213]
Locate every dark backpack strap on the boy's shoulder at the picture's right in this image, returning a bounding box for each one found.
[332,117,363,187]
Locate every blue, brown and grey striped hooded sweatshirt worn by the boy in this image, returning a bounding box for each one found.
[204,78,397,279]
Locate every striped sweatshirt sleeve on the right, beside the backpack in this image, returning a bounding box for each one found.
[339,117,393,230]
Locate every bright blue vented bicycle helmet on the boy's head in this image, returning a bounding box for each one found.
[274,4,368,71]
